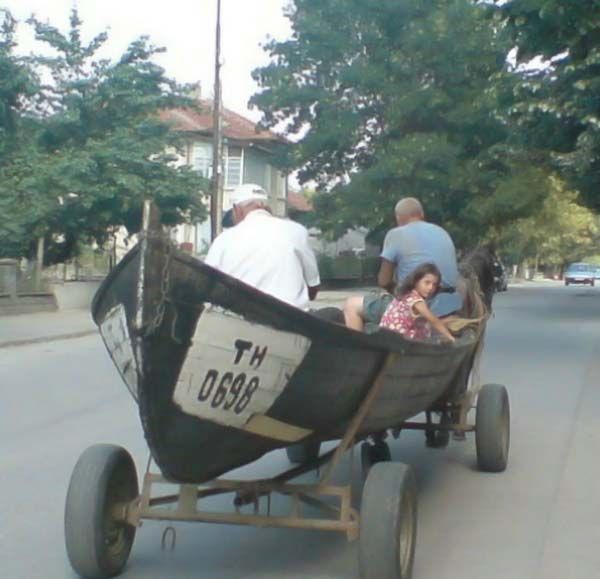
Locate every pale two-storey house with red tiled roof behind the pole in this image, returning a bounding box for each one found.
[161,100,288,254]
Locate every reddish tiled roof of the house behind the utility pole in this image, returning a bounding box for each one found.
[160,100,285,142]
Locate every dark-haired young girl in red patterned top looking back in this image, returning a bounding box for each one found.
[379,263,455,342]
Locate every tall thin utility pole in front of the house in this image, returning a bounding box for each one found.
[210,0,223,240]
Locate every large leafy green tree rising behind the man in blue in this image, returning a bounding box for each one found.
[251,0,546,244]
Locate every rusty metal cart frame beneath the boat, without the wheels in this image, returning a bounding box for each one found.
[113,353,478,541]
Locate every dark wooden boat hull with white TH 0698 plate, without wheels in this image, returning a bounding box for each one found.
[92,205,493,483]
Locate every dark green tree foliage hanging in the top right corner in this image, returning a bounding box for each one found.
[499,0,600,210]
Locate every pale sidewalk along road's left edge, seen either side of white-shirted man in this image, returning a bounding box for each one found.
[0,287,372,348]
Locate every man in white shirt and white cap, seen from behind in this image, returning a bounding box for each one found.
[205,184,321,310]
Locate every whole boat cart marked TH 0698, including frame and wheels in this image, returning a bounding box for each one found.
[65,204,509,579]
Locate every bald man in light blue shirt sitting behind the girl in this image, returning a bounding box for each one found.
[344,197,462,331]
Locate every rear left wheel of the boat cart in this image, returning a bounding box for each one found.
[65,444,139,579]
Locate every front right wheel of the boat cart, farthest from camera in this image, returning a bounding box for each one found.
[475,384,510,472]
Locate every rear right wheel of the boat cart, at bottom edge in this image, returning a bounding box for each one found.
[358,462,417,579]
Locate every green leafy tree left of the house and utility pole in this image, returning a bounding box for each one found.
[0,10,207,261]
